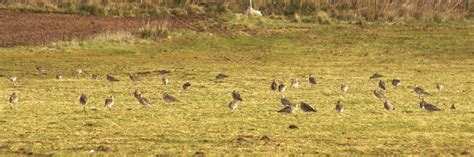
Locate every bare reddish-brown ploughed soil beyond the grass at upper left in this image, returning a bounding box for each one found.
[0,10,208,47]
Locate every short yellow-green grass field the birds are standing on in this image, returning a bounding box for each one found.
[0,17,474,155]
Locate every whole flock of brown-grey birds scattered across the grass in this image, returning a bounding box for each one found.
[3,65,456,114]
